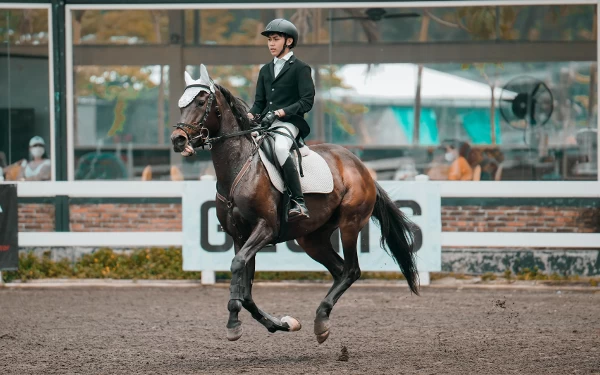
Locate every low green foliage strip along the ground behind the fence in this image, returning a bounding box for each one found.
[2,248,600,287]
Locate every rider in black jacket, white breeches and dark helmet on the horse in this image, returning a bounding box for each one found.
[248,18,315,221]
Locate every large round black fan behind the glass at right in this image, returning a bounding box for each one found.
[500,76,554,130]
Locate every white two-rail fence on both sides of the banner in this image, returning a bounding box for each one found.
[8,181,600,284]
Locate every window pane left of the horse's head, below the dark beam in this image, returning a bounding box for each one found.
[74,66,170,179]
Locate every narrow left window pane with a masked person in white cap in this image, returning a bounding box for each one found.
[0,9,53,181]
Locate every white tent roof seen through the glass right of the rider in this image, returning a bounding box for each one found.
[330,64,502,102]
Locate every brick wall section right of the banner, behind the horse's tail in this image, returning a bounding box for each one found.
[442,206,600,233]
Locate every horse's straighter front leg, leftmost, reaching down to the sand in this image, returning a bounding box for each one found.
[227,219,275,341]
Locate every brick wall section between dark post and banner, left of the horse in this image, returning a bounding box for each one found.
[70,203,182,232]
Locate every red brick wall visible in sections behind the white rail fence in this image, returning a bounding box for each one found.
[19,203,600,233]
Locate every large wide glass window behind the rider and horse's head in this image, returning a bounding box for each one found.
[73,5,598,181]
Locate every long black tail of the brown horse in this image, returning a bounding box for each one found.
[373,182,419,295]
